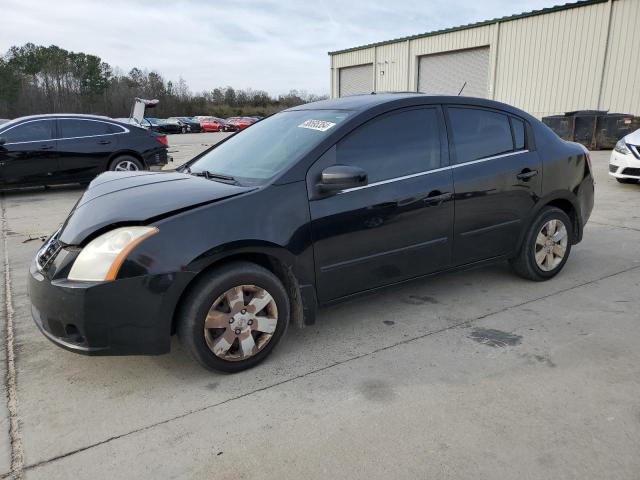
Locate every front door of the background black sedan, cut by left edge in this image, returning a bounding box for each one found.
[0,119,59,186]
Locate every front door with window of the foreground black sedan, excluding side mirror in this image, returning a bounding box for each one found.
[308,107,453,302]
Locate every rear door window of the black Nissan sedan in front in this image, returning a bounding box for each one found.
[448,107,513,163]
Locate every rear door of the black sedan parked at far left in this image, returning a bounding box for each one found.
[58,118,126,181]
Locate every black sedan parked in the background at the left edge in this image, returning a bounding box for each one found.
[0,115,168,188]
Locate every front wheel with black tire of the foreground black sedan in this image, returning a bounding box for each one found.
[177,262,290,373]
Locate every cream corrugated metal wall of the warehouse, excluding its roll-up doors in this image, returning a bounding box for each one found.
[331,0,640,117]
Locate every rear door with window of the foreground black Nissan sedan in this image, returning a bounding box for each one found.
[446,106,542,265]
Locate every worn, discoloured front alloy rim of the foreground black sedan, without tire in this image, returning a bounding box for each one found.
[204,285,278,362]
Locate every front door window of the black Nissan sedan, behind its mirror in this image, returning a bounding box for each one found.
[336,108,440,183]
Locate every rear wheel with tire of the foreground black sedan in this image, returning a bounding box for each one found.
[509,207,573,282]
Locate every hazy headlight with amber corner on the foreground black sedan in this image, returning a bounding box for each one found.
[68,227,159,282]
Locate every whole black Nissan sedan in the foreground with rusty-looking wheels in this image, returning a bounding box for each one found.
[29,94,594,372]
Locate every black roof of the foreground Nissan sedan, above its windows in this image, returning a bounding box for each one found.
[288,92,533,118]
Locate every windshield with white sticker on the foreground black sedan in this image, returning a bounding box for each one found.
[189,110,350,184]
